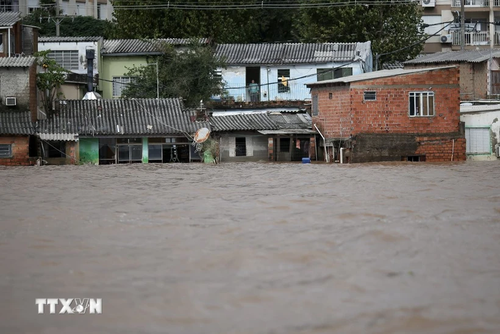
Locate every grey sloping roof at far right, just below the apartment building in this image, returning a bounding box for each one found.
[404,50,500,65]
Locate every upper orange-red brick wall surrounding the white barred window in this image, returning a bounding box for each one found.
[311,68,460,138]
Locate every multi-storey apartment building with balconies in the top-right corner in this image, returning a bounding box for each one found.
[419,0,500,53]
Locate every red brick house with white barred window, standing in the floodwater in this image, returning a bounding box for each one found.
[307,66,465,162]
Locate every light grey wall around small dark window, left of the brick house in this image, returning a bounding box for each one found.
[220,133,269,162]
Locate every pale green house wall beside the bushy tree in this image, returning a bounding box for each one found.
[101,56,147,99]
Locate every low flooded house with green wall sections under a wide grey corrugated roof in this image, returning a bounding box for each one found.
[37,98,210,164]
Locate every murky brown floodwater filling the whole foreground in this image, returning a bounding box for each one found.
[0,161,500,334]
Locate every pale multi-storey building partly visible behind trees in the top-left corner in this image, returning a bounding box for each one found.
[0,0,113,20]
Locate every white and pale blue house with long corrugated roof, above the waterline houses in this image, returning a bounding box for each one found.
[214,42,373,103]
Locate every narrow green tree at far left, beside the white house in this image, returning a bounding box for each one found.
[35,50,69,115]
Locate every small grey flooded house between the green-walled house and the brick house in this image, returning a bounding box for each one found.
[210,110,315,162]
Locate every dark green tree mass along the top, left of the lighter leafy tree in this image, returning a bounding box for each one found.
[113,0,293,43]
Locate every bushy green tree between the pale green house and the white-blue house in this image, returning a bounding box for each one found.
[123,42,224,107]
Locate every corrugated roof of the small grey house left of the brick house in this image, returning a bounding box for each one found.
[210,112,311,132]
